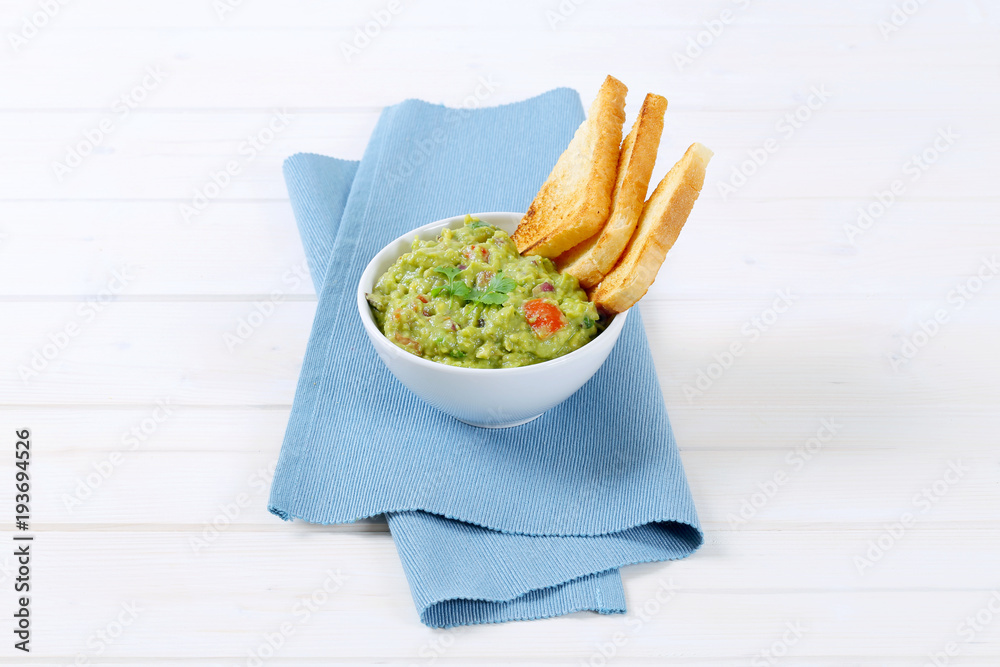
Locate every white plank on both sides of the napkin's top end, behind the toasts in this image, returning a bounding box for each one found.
[0,109,1000,201]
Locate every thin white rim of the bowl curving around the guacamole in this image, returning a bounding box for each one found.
[357,211,628,376]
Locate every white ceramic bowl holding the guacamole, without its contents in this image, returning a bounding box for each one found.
[358,213,628,428]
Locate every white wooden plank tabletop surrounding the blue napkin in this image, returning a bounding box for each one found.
[0,0,1000,667]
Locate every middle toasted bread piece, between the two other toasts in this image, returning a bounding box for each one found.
[556,93,667,287]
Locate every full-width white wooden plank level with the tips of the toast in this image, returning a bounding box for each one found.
[1,23,1000,111]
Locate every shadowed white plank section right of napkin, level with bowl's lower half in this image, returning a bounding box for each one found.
[645,296,1000,413]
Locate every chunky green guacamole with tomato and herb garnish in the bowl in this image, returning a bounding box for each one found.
[367,215,598,368]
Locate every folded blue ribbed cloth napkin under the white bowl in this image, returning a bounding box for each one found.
[268,89,702,627]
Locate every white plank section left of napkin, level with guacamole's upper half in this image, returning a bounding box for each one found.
[0,201,315,300]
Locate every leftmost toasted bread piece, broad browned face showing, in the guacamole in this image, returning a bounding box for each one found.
[512,76,628,257]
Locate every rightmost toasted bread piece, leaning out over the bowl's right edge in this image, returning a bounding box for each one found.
[590,143,713,313]
